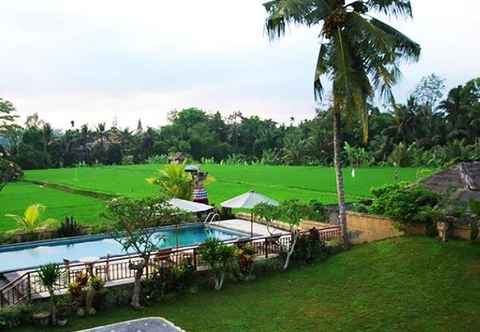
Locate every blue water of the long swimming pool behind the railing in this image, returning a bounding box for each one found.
[0,225,248,272]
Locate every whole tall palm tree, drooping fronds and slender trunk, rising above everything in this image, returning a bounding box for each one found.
[264,0,420,246]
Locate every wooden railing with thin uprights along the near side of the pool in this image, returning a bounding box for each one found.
[0,226,340,308]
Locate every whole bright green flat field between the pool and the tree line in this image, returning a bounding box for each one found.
[0,165,428,231]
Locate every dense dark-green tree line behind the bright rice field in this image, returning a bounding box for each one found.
[0,74,480,169]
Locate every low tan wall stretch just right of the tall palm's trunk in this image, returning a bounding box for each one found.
[347,212,405,244]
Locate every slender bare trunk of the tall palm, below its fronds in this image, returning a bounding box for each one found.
[333,109,350,248]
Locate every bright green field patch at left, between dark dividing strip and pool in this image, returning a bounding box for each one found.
[0,182,104,231]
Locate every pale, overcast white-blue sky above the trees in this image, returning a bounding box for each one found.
[0,0,480,129]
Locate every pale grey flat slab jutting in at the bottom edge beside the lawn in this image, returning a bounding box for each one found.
[78,317,184,332]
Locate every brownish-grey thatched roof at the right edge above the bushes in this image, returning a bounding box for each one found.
[422,161,480,201]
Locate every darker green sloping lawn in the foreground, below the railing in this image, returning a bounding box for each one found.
[13,237,480,332]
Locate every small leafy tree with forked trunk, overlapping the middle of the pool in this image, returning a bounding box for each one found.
[105,197,181,308]
